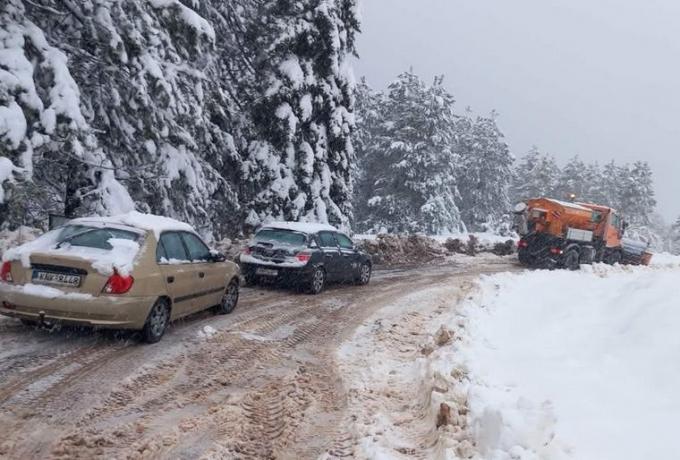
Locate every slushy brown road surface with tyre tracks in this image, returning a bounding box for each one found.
[0,256,517,459]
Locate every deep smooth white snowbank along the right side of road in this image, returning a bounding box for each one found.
[446,265,680,460]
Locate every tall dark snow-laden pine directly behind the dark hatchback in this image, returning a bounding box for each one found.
[243,0,359,227]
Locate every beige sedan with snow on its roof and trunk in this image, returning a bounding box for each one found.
[0,213,239,342]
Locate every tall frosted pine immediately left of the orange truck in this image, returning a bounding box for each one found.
[456,110,514,231]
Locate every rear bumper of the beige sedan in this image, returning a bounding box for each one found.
[0,283,156,329]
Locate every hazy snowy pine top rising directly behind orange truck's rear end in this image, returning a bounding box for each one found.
[510,146,560,203]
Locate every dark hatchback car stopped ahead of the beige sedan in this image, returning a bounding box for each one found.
[240,222,372,294]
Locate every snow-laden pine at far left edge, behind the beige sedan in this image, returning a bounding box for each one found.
[0,0,133,225]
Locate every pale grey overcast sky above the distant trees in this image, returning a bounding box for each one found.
[356,0,680,220]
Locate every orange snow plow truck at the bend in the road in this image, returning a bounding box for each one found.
[515,198,651,270]
